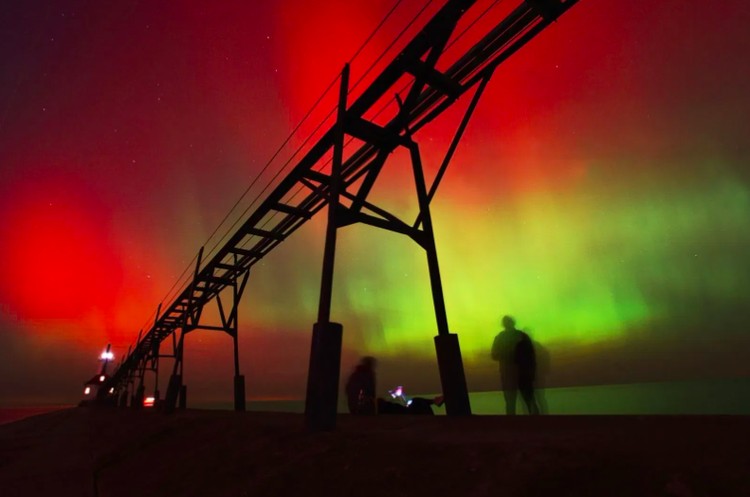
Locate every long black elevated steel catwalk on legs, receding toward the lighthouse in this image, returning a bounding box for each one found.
[101,0,578,430]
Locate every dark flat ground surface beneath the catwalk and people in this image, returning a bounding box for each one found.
[0,408,750,497]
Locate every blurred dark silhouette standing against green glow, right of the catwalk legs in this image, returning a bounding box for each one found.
[492,316,539,415]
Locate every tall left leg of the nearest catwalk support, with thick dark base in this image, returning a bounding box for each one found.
[305,64,349,431]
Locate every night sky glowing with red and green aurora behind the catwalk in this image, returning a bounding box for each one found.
[0,0,750,404]
